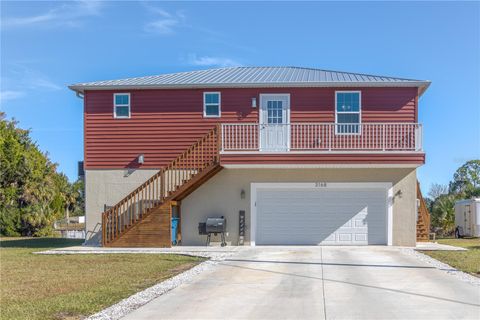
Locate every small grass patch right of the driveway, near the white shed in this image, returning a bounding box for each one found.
[423,238,480,277]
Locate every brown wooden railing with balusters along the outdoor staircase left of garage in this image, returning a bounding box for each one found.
[102,125,221,246]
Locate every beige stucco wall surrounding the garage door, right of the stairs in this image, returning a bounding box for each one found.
[181,169,416,246]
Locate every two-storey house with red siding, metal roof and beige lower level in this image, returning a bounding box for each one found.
[69,67,430,247]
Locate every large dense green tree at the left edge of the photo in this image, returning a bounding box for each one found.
[0,113,81,236]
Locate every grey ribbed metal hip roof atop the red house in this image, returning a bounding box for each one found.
[69,67,430,94]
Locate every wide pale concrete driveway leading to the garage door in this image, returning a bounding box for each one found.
[125,247,480,320]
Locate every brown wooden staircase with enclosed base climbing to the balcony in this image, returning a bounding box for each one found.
[102,126,222,247]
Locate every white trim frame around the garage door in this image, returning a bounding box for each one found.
[250,182,393,246]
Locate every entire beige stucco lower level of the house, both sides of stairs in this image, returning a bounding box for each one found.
[86,168,416,246]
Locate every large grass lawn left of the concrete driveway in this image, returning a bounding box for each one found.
[0,238,203,320]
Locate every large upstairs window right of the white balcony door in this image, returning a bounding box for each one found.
[335,91,362,134]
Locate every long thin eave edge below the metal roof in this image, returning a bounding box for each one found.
[68,81,431,95]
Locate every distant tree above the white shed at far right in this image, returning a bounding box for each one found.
[449,160,480,198]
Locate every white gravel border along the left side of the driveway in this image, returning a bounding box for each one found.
[85,251,240,320]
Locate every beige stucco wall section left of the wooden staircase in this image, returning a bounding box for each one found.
[85,169,158,245]
